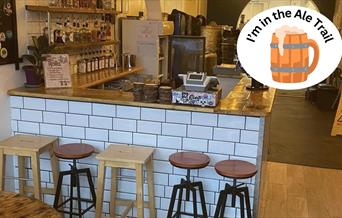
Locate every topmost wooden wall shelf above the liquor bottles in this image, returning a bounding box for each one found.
[26,5,117,15]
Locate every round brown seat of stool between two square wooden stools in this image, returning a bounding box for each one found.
[54,143,95,159]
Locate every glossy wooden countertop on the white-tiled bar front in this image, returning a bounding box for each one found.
[8,77,275,116]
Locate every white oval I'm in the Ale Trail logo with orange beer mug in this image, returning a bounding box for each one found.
[237,6,342,90]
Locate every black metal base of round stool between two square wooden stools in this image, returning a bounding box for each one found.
[53,160,96,218]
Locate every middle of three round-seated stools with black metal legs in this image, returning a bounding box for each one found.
[167,152,210,218]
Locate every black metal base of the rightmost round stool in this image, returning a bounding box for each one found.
[214,179,252,218]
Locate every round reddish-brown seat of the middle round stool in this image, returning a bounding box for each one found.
[169,152,210,169]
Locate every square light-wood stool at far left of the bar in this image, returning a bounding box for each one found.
[0,134,59,200]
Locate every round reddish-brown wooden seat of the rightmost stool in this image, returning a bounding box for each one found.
[215,160,257,179]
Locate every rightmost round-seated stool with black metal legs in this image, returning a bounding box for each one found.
[214,160,257,218]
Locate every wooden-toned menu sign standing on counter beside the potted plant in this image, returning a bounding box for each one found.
[43,54,72,88]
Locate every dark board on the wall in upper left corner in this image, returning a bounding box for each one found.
[0,0,18,65]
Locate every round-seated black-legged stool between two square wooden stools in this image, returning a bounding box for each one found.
[53,143,96,217]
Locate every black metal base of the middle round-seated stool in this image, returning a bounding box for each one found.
[167,170,208,218]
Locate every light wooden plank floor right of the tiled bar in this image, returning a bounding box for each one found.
[259,162,342,218]
